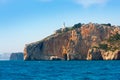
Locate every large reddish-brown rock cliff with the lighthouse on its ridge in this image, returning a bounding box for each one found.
[24,23,120,60]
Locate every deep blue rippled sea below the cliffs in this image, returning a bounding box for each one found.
[0,61,120,80]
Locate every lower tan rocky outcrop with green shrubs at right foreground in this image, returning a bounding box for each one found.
[87,33,120,60]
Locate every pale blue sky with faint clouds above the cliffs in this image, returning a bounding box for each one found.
[0,0,120,53]
